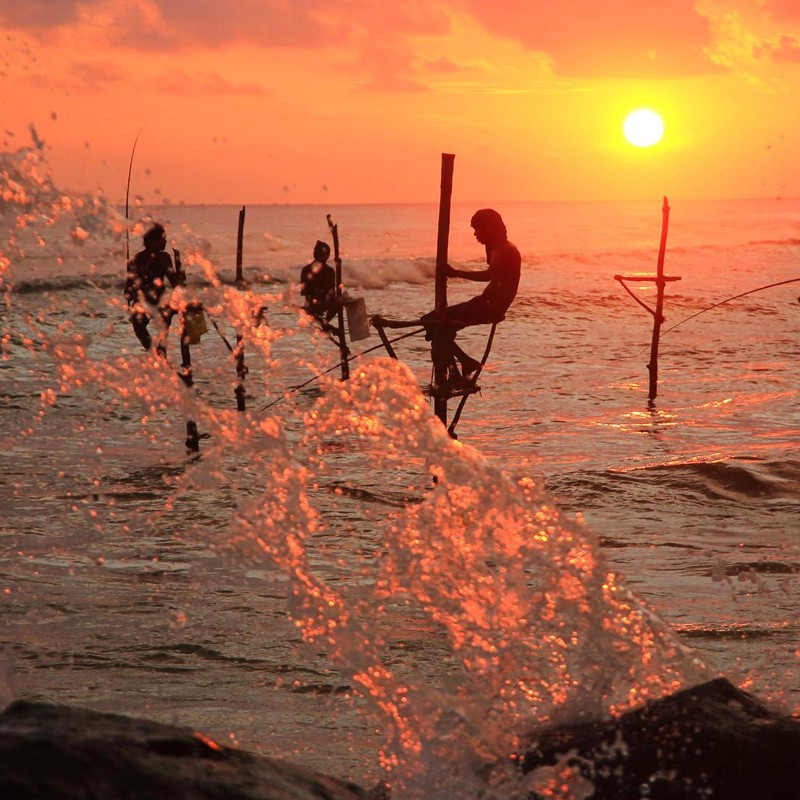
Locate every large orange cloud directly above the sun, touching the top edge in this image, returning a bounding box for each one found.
[465,0,715,78]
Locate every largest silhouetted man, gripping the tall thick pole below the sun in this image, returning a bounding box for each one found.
[420,208,522,386]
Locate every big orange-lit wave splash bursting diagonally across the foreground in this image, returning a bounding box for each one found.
[0,141,705,800]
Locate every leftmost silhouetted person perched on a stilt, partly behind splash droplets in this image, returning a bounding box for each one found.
[125,223,186,354]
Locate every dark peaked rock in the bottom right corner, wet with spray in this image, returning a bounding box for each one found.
[522,678,800,800]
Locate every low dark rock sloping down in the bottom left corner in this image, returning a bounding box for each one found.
[0,701,368,800]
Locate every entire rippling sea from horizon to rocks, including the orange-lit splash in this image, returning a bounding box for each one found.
[0,145,800,800]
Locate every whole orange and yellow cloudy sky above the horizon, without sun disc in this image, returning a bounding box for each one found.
[0,0,800,204]
